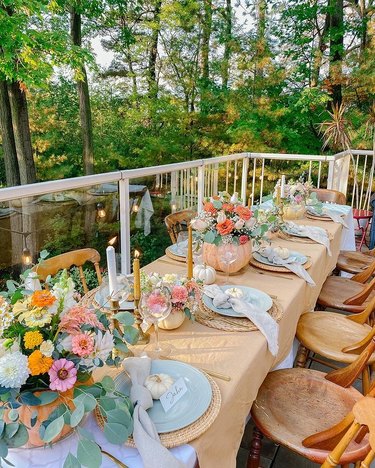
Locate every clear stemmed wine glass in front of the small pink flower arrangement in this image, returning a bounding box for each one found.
[139,285,172,359]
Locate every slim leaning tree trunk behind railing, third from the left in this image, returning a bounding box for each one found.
[70,8,94,175]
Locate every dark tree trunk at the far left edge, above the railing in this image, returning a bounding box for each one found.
[0,80,21,187]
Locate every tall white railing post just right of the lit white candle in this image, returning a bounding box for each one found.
[119,179,130,275]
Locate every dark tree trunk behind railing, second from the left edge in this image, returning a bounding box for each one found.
[8,81,36,184]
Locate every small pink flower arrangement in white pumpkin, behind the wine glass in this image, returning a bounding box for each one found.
[141,272,200,330]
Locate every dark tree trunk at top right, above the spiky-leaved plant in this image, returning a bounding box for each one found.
[329,0,344,106]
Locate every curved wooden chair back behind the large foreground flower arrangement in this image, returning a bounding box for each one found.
[33,249,102,294]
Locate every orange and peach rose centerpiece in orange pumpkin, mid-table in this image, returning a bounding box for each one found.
[192,192,274,273]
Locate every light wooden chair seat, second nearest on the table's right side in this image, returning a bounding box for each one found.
[296,312,375,364]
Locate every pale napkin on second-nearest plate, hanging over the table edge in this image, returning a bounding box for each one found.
[203,284,279,356]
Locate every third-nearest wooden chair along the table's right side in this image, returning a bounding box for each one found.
[317,259,375,313]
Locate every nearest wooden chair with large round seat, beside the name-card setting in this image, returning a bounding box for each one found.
[247,339,375,468]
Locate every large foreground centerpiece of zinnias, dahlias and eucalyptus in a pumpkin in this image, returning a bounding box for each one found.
[0,271,137,466]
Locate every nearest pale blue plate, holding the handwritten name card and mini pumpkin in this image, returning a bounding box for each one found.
[115,360,212,434]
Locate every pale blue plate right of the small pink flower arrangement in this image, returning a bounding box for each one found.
[202,284,273,318]
